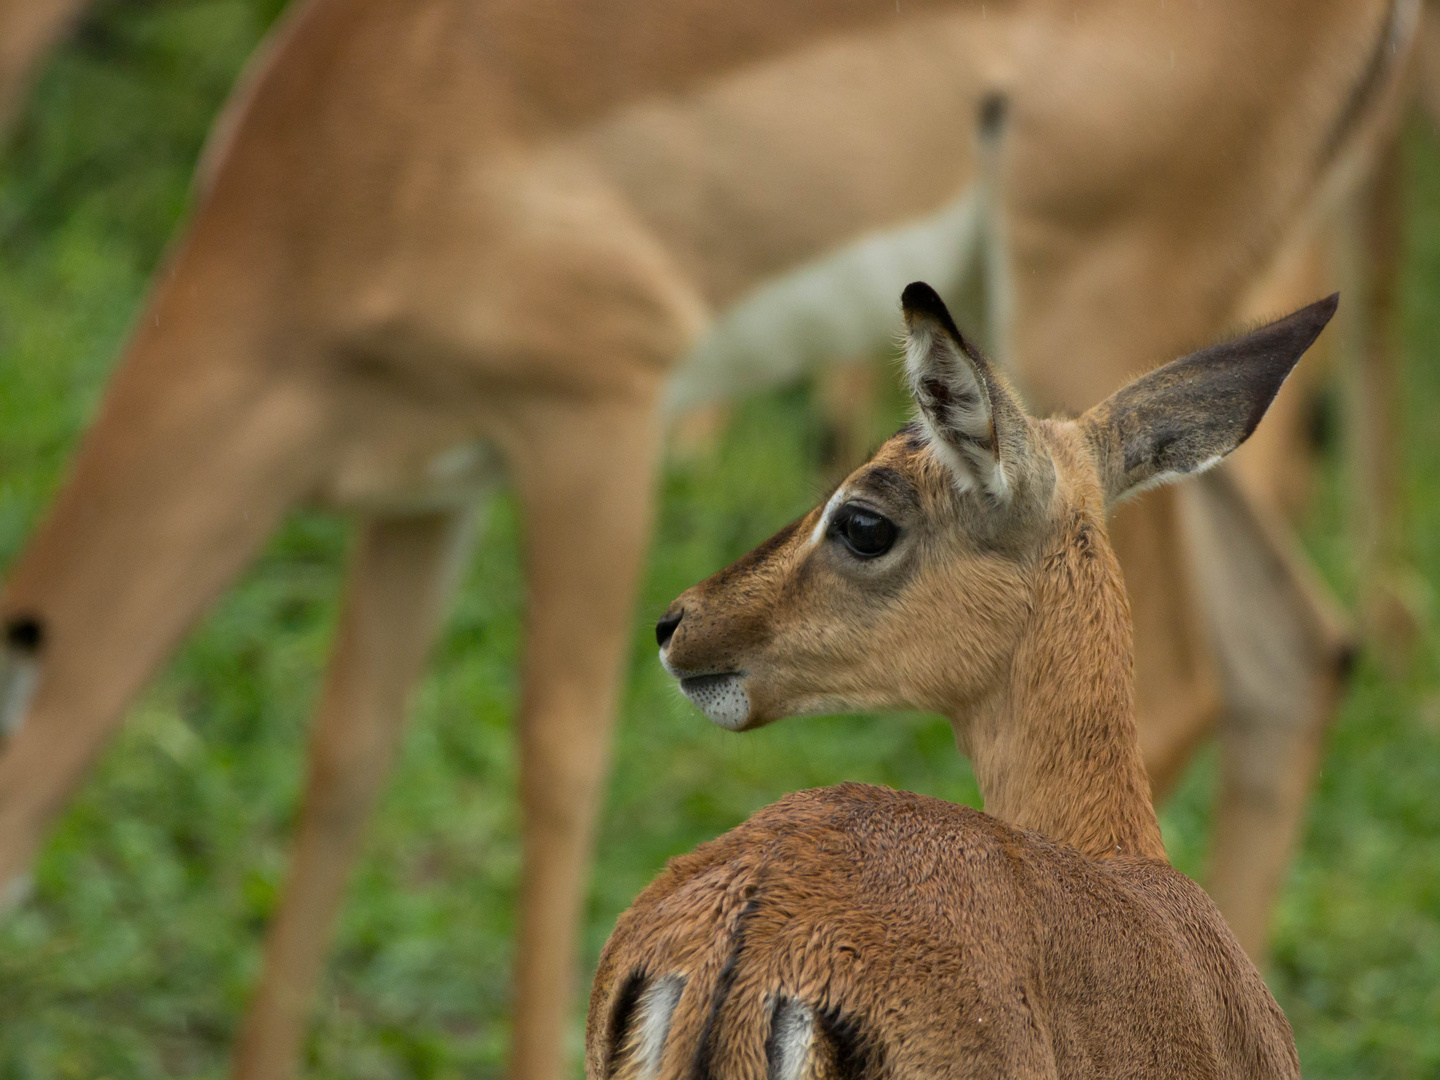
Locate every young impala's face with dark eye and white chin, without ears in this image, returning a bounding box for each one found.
[657,426,1042,730]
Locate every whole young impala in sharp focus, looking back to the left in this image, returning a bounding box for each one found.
[586,282,1336,1080]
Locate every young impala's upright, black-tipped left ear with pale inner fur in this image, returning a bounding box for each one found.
[900,281,1035,505]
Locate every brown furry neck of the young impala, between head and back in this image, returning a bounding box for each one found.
[956,514,1165,860]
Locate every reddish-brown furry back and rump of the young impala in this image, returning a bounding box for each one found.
[586,783,1299,1080]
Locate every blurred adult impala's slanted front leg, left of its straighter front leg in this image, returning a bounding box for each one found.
[233,513,474,1080]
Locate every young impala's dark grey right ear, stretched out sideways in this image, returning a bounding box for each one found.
[1080,292,1339,505]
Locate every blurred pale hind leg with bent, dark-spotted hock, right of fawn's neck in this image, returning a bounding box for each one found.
[1181,469,1354,959]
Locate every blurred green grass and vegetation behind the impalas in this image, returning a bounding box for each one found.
[0,0,1440,1080]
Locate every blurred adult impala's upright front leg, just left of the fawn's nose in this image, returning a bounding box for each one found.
[511,402,660,1080]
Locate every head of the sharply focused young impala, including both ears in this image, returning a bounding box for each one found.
[657,284,1336,730]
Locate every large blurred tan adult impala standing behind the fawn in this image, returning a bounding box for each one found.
[0,0,1414,1079]
